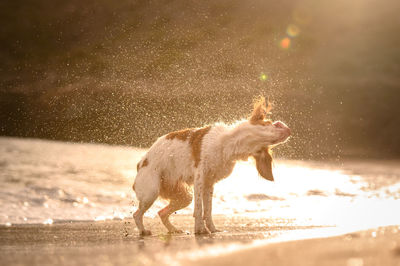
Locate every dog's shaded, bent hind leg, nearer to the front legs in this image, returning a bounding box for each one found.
[158,183,192,233]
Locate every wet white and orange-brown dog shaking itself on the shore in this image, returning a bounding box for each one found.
[133,97,291,236]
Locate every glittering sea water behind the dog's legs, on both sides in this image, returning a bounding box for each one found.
[0,137,400,229]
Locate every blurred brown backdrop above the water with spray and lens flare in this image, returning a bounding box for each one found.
[0,0,400,159]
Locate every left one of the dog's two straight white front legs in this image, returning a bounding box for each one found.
[193,173,209,234]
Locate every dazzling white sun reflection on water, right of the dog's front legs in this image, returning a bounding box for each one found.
[213,161,400,230]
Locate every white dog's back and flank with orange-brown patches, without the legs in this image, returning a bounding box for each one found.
[133,127,211,202]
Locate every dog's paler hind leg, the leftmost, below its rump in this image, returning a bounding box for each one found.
[133,172,160,236]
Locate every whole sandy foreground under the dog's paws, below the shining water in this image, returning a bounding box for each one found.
[0,215,400,266]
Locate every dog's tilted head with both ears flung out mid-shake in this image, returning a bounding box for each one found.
[248,98,290,181]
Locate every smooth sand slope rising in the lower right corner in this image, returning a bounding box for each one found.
[191,226,400,266]
